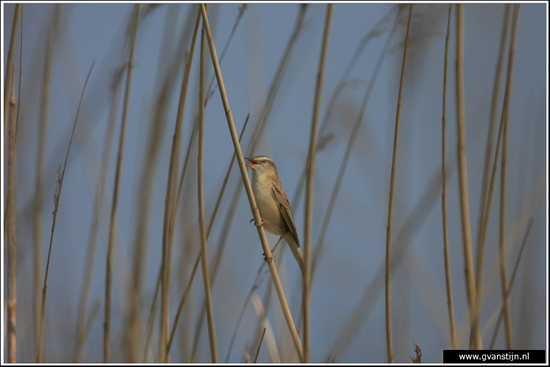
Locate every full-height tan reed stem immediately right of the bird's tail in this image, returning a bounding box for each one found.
[303,4,333,363]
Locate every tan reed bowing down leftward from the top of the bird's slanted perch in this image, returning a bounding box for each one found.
[159,5,200,362]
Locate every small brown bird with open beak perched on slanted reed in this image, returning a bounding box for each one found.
[246,155,305,276]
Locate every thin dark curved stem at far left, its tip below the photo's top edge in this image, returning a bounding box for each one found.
[36,60,95,363]
